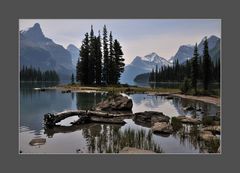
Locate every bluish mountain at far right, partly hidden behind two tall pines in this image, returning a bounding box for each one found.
[172,35,220,64]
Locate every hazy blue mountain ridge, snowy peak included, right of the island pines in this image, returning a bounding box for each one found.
[121,35,221,84]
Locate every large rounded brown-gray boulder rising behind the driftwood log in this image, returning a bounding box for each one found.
[95,95,133,111]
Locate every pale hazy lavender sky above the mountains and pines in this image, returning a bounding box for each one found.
[19,19,221,64]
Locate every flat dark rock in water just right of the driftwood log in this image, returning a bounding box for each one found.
[133,111,170,127]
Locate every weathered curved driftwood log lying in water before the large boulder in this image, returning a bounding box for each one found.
[44,110,134,127]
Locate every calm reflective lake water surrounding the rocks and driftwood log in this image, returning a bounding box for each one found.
[19,83,220,153]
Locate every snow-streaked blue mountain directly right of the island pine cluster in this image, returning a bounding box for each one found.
[120,52,171,84]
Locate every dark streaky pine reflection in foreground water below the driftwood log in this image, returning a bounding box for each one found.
[82,124,163,153]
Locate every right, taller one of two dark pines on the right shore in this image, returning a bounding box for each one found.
[203,37,211,91]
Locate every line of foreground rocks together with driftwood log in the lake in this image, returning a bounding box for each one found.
[44,95,221,145]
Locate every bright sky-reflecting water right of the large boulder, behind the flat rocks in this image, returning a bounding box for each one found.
[129,94,220,118]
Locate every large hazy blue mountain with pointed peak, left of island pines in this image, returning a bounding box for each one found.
[20,23,73,80]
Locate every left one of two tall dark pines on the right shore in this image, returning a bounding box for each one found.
[191,44,199,94]
